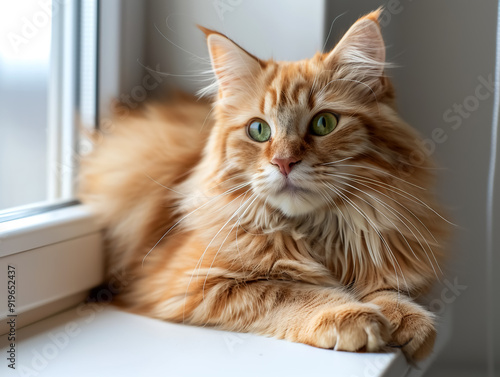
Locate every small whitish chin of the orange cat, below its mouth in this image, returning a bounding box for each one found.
[267,192,325,217]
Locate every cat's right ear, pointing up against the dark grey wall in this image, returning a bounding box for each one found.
[324,8,387,86]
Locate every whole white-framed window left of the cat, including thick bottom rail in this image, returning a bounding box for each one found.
[0,0,102,334]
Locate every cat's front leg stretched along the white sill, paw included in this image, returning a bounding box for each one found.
[176,279,390,351]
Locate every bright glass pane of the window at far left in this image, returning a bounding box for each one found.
[0,0,52,210]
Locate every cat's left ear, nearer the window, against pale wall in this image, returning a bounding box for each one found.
[198,26,264,96]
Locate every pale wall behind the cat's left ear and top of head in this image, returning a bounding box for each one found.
[146,0,325,91]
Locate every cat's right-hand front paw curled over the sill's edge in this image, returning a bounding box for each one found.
[361,290,436,361]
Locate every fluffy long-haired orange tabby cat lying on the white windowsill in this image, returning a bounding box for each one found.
[80,11,446,360]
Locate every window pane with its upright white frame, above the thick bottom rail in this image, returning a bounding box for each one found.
[0,0,97,219]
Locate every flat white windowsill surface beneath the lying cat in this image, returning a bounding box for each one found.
[0,304,414,377]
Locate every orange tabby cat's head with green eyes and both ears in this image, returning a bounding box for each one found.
[204,11,428,216]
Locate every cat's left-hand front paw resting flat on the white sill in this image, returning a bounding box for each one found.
[304,303,390,352]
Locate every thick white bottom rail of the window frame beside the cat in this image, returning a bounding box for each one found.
[0,205,104,335]
